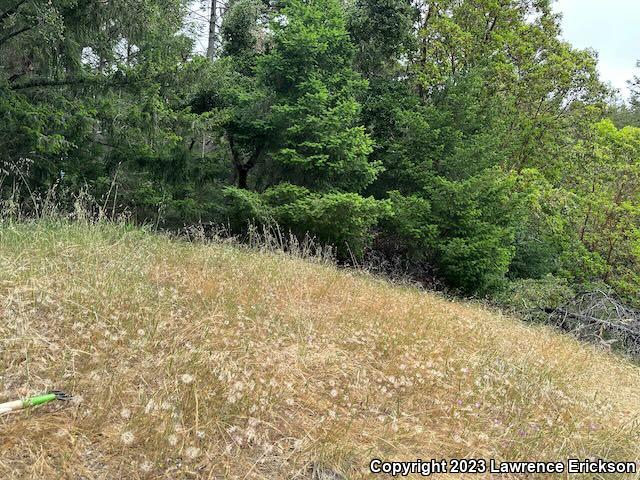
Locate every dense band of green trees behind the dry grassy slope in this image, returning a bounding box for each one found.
[0,0,640,301]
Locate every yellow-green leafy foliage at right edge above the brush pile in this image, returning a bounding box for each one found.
[566,120,640,302]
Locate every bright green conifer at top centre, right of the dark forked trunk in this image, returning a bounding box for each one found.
[259,0,380,191]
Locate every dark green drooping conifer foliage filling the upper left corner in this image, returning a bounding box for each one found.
[0,0,199,219]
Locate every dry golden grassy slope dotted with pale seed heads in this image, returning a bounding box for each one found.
[0,224,640,479]
